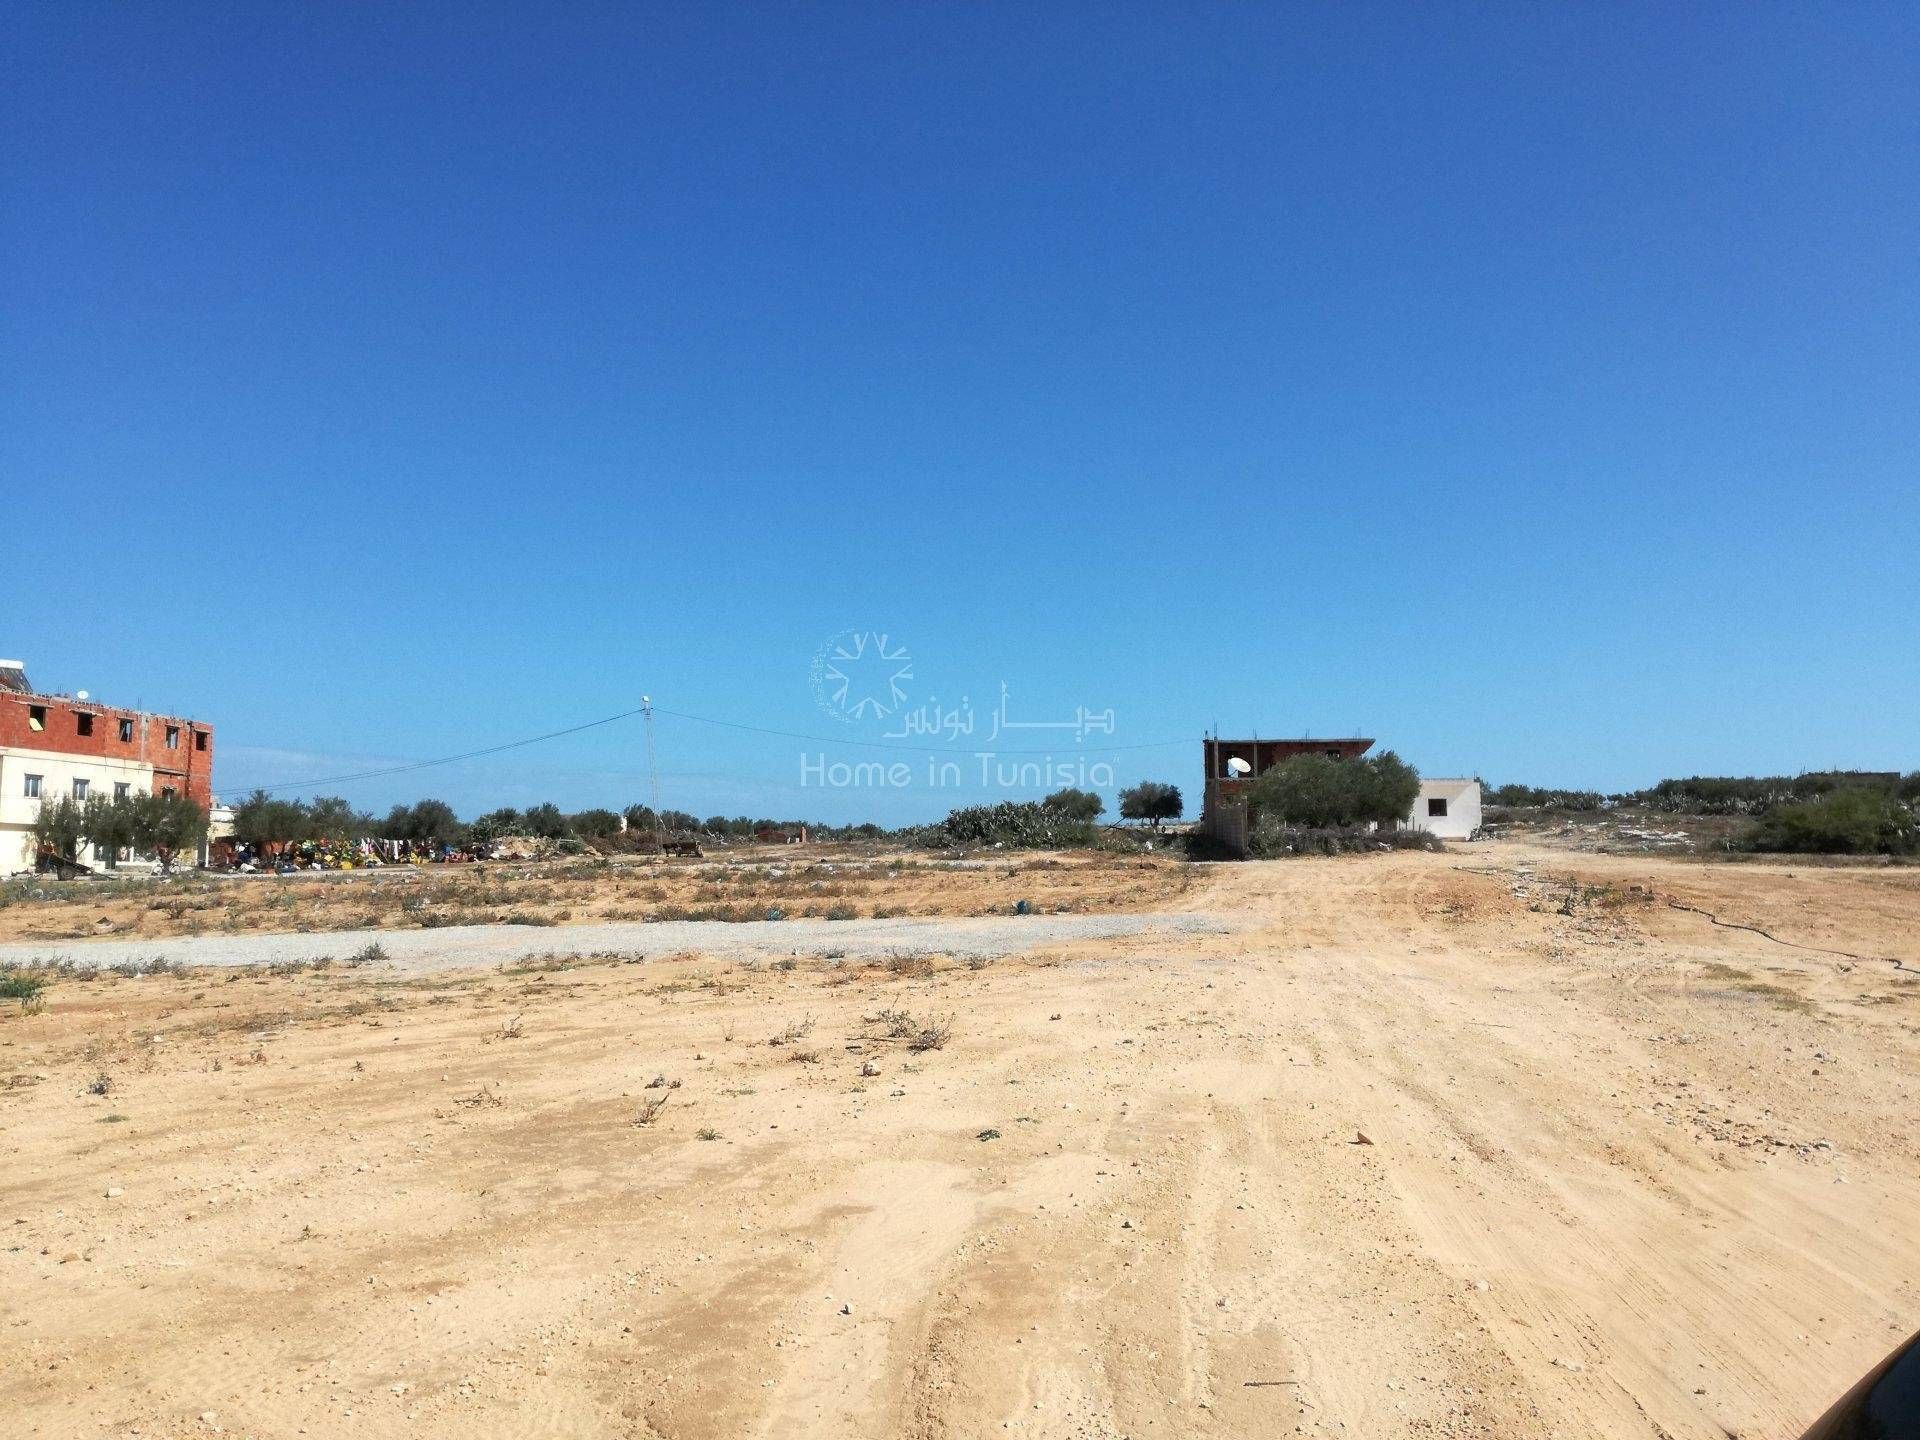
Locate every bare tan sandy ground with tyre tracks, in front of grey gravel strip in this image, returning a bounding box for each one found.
[0,845,1920,1440]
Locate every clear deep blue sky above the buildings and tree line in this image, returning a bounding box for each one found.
[0,4,1920,822]
